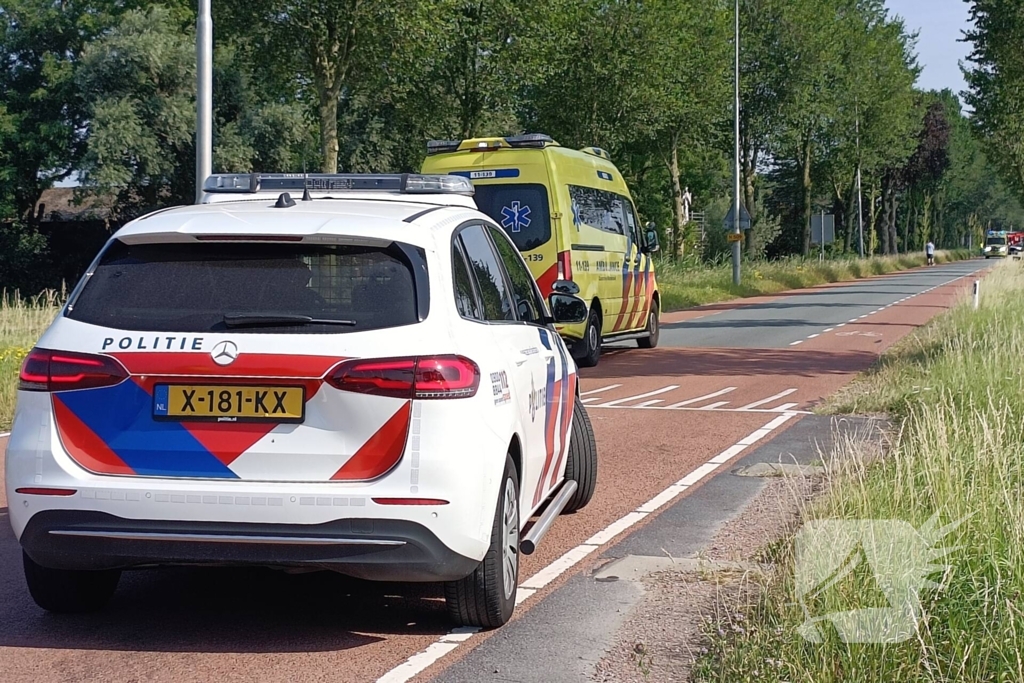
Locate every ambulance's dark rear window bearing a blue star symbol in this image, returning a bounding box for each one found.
[474,183,551,252]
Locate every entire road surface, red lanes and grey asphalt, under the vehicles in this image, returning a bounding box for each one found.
[0,261,985,683]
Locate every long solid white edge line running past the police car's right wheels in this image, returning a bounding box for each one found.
[377,413,797,683]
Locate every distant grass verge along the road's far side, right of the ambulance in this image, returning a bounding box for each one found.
[656,251,972,311]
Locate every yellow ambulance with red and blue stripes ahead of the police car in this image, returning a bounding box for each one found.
[423,133,660,367]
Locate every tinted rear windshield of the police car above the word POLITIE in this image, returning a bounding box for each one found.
[68,241,426,334]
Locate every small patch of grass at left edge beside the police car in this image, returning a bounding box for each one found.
[0,291,62,431]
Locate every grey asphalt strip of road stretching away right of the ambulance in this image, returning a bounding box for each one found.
[660,260,990,348]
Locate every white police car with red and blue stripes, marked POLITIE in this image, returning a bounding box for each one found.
[6,174,597,628]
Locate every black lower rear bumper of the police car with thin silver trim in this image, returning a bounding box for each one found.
[20,510,478,582]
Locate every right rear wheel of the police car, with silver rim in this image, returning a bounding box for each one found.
[444,457,519,629]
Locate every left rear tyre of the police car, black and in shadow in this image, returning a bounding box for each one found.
[22,552,121,612]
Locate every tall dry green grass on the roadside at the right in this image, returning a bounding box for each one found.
[694,261,1024,683]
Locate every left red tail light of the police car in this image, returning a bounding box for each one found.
[17,348,128,391]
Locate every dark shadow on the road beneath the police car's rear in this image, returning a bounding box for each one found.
[0,518,452,653]
